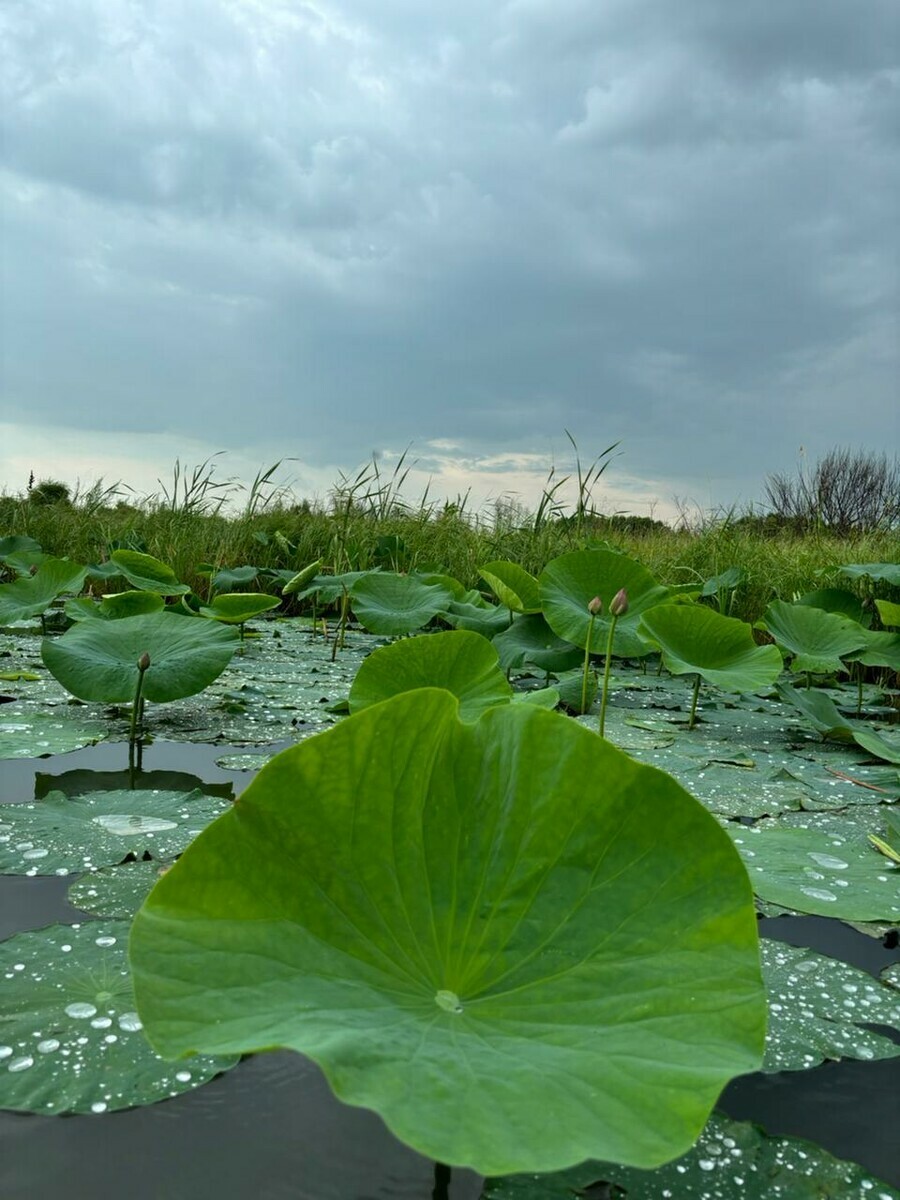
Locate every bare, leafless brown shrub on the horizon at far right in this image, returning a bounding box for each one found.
[766,446,900,533]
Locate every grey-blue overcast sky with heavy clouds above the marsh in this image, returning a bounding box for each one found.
[0,0,900,516]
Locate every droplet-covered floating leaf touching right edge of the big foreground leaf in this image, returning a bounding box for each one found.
[760,937,900,1072]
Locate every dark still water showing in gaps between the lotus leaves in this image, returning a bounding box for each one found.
[0,742,900,1200]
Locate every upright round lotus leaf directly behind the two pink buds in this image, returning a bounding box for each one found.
[540,550,668,658]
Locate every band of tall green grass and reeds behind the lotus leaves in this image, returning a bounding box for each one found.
[0,443,900,622]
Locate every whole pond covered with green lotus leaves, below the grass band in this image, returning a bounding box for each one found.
[0,544,900,1200]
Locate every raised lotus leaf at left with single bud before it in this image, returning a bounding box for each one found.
[41,612,238,704]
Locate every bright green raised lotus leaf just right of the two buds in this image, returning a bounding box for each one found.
[638,605,781,691]
